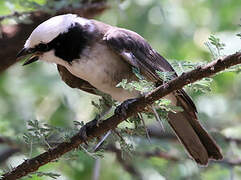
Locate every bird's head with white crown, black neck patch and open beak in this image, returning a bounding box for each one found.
[17,14,94,65]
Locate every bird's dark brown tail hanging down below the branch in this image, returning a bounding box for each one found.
[168,94,223,165]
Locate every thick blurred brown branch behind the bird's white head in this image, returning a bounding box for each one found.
[0,0,108,73]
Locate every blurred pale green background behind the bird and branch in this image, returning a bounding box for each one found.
[0,0,241,180]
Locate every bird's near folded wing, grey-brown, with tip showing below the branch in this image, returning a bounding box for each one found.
[103,28,197,112]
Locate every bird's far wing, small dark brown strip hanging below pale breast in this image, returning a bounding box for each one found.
[57,65,97,95]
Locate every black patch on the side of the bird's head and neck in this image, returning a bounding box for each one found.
[46,23,93,62]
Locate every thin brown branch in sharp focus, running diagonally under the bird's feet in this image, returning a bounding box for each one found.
[2,52,241,180]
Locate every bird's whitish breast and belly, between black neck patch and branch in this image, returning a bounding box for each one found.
[65,43,140,102]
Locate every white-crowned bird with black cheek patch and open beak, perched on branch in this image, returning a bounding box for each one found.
[17,14,223,166]
